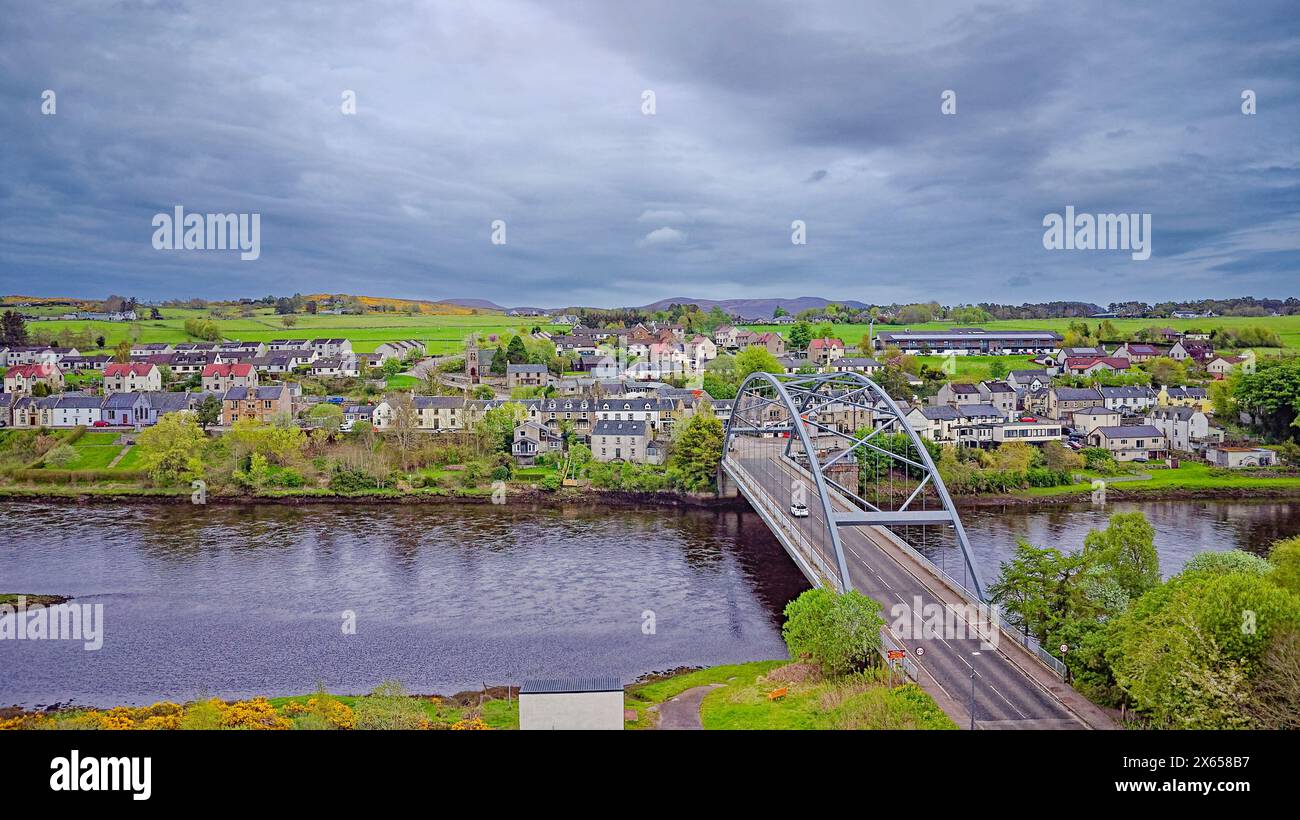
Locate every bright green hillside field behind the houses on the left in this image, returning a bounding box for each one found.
[27,308,561,355]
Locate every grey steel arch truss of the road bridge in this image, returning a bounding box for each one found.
[720,373,987,600]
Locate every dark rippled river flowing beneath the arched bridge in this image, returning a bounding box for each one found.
[0,502,1300,707]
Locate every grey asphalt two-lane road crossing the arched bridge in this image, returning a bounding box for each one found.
[727,438,1110,729]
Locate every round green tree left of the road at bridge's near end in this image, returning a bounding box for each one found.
[781,587,885,676]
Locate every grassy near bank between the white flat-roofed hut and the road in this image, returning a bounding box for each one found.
[625,660,957,729]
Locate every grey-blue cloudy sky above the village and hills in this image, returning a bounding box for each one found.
[0,0,1300,305]
